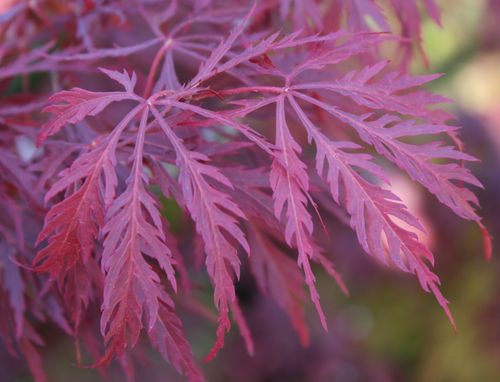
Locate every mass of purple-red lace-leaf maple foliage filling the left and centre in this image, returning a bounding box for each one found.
[0,0,490,381]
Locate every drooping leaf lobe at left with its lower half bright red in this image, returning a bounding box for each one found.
[34,107,143,278]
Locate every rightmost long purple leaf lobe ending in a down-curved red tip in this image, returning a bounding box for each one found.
[294,92,491,258]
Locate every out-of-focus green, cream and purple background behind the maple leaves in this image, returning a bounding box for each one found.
[0,0,500,382]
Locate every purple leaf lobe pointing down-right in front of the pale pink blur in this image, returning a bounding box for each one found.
[288,95,455,326]
